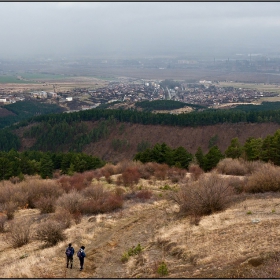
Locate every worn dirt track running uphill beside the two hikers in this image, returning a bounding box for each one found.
[50,201,175,278]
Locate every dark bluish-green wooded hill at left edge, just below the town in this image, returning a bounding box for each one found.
[0,100,63,128]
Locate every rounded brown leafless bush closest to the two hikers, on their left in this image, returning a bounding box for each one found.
[36,220,66,246]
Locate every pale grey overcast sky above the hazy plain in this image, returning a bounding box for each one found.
[0,2,280,58]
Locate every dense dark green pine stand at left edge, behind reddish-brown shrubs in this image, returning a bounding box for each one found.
[0,150,105,180]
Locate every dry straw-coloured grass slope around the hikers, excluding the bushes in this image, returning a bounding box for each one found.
[0,168,280,278]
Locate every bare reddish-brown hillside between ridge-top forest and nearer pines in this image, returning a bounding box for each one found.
[15,121,280,163]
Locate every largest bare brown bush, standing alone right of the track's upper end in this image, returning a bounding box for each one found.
[171,173,234,217]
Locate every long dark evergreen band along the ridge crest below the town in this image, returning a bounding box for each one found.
[14,106,280,131]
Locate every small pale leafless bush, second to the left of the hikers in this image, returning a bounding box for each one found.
[8,220,31,248]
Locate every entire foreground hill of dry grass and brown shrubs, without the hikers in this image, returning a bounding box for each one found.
[0,161,280,278]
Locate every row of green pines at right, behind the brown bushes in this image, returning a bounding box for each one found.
[134,130,280,171]
